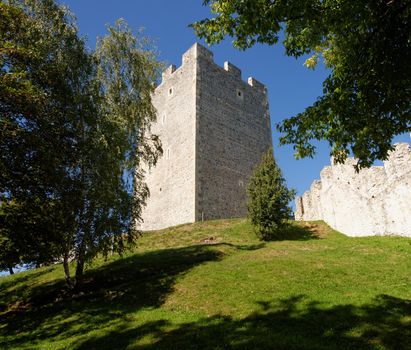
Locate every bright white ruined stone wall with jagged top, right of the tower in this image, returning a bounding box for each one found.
[296,143,411,237]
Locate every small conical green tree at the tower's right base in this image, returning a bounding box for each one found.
[247,149,295,241]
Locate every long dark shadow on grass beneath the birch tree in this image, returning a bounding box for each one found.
[0,246,222,349]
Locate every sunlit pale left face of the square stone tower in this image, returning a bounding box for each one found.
[141,43,197,230]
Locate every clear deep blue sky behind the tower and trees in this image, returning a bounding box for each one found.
[60,0,409,194]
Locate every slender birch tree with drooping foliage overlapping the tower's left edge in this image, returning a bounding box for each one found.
[64,20,162,285]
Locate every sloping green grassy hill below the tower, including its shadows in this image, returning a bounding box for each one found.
[0,220,411,350]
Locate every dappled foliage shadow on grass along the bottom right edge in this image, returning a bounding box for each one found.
[75,295,411,350]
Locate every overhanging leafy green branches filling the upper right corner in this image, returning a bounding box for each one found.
[193,0,411,167]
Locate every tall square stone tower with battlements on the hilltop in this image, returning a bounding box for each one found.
[141,43,272,230]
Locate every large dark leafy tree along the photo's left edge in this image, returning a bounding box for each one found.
[0,0,93,274]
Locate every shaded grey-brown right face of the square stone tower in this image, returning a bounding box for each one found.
[196,45,271,220]
